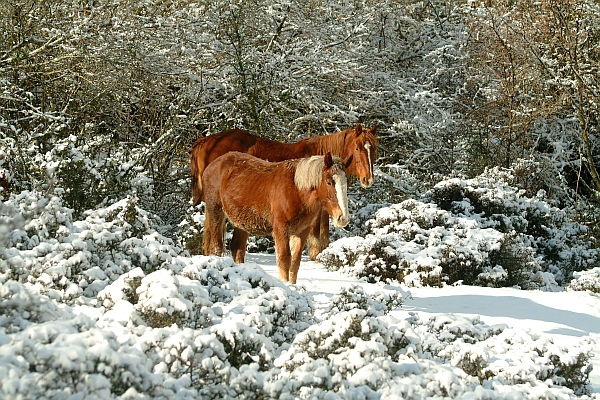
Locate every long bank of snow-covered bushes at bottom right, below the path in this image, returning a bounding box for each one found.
[268,309,590,399]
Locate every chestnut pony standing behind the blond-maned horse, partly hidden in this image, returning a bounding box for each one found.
[190,124,377,262]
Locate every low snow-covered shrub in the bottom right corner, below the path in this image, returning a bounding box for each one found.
[423,315,591,395]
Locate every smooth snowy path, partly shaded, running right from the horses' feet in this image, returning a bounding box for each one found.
[246,253,600,393]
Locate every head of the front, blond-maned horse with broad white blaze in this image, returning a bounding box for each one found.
[318,153,353,228]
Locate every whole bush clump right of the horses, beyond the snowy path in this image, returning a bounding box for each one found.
[319,172,598,289]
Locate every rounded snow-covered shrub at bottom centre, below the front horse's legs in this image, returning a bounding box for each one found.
[275,309,420,394]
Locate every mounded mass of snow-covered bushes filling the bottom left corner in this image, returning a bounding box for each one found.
[0,248,313,398]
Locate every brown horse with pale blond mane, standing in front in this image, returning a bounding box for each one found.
[202,152,352,283]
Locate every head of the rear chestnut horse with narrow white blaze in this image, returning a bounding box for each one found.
[344,124,377,187]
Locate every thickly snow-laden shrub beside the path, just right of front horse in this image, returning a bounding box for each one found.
[319,200,503,286]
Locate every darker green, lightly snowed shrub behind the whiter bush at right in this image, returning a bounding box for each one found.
[425,176,598,283]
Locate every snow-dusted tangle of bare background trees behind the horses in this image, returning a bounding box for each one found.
[0,0,600,234]
